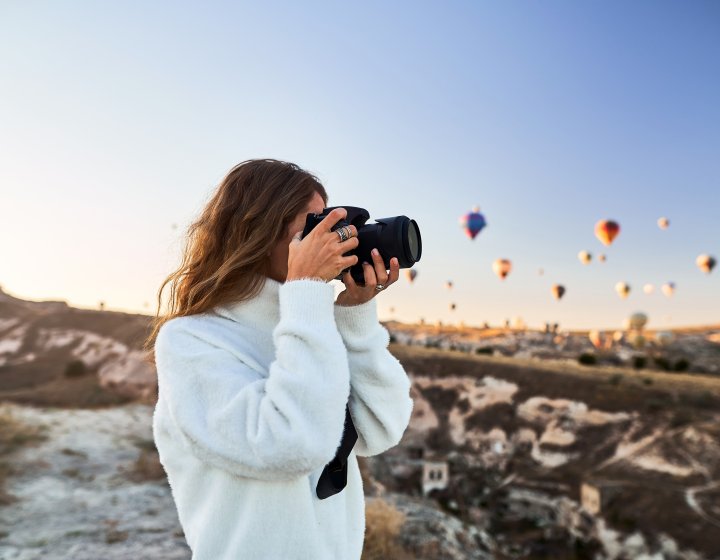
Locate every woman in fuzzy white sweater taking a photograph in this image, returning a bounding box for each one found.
[146,159,413,560]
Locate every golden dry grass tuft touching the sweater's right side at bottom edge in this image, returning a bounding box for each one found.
[362,498,414,560]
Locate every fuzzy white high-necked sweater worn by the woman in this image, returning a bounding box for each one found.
[153,278,413,560]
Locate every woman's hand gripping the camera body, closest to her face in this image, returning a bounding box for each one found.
[287,208,360,282]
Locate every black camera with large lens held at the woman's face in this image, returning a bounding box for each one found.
[302,206,422,285]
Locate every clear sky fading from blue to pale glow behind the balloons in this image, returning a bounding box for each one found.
[0,0,720,328]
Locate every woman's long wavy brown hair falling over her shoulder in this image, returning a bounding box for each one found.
[143,159,327,363]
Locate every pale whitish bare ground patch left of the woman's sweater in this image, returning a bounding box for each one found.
[0,403,191,560]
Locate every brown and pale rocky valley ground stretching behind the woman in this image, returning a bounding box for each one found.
[0,292,720,560]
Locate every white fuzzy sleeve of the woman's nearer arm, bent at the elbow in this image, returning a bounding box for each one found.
[155,279,350,480]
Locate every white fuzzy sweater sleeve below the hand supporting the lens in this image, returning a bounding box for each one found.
[335,298,413,457]
